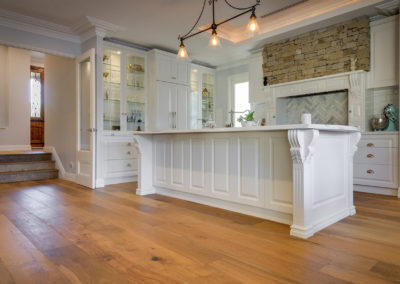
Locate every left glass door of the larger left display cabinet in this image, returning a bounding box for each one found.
[103,49,121,130]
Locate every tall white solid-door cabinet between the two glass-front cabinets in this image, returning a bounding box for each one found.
[148,50,190,130]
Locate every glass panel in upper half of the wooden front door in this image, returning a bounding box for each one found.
[30,66,44,119]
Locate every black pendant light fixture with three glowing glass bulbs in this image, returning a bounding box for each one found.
[177,0,260,59]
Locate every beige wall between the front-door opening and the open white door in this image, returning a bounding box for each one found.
[44,54,76,173]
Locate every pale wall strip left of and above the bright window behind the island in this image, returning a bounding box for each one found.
[215,62,249,127]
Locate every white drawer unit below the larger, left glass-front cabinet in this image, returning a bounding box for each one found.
[103,136,138,185]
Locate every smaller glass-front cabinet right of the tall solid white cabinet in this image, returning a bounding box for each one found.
[190,64,215,129]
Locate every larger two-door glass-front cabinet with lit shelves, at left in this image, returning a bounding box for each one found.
[103,45,147,132]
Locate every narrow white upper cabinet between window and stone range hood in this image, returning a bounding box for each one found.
[249,52,265,103]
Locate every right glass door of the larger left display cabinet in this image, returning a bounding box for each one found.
[126,54,146,131]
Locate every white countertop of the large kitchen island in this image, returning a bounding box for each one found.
[131,124,360,135]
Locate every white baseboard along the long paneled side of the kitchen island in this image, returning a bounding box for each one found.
[155,187,293,225]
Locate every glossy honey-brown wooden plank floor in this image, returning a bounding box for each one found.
[0,180,400,284]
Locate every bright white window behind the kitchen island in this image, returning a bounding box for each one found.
[230,73,250,127]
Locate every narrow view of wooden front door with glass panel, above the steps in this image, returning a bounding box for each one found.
[31,66,44,147]
